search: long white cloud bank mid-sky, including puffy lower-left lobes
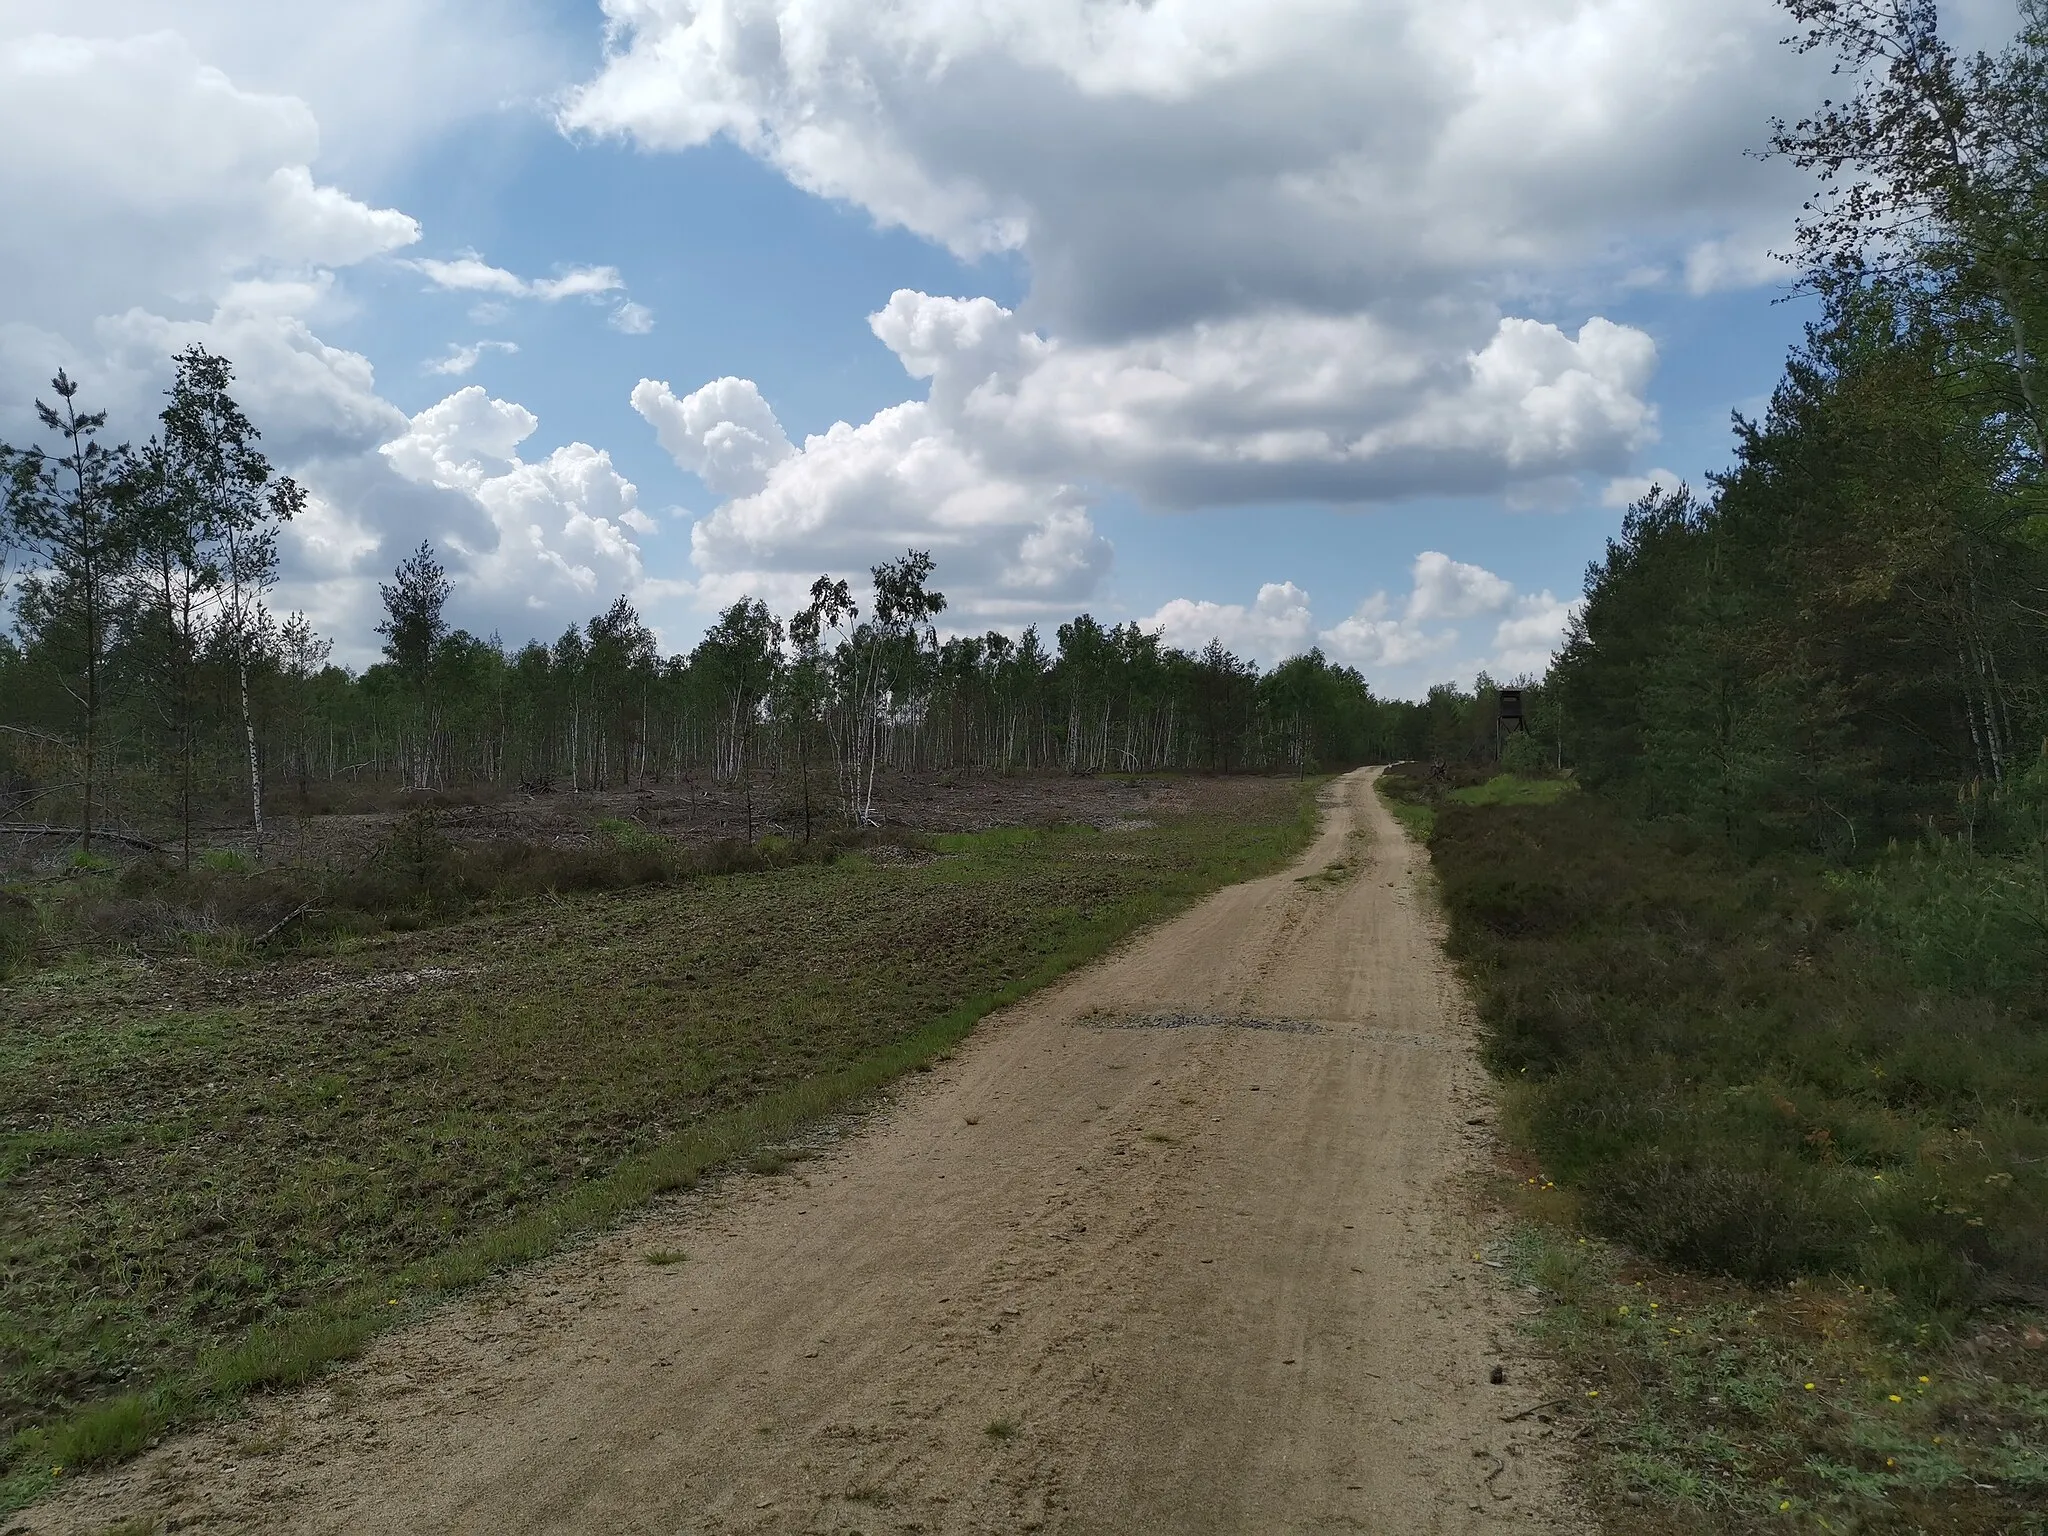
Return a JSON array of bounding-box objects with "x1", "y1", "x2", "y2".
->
[{"x1": 631, "y1": 289, "x2": 1655, "y2": 623}]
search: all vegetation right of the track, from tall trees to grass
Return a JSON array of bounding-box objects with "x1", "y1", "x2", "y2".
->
[{"x1": 1449, "y1": 0, "x2": 2048, "y2": 1536}]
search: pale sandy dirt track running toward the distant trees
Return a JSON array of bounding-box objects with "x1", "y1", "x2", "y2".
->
[{"x1": 19, "y1": 774, "x2": 1581, "y2": 1534}]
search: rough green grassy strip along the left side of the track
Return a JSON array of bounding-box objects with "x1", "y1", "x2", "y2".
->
[{"x1": 0, "y1": 780, "x2": 1315, "y2": 1507}]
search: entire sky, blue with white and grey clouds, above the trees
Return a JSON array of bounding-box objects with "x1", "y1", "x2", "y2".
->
[{"x1": 0, "y1": 0, "x2": 2009, "y2": 694}]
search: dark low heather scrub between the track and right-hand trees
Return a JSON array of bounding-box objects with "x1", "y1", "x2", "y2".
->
[{"x1": 1432, "y1": 795, "x2": 2048, "y2": 1325}]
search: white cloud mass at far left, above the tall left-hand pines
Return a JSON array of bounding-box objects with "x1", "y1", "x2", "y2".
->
[{"x1": 0, "y1": 25, "x2": 657, "y2": 664}]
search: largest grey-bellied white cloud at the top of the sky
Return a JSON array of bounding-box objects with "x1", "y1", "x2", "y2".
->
[{"x1": 561, "y1": 0, "x2": 1815, "y2": 334}]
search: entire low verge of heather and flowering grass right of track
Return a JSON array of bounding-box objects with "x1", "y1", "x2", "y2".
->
[{"x1": 1432, "y1": 795, "x2": 2048, "y2": 1536}]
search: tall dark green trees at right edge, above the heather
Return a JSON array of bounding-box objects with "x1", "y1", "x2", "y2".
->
[{"x1": 1550, "y1": 0, "x2": 2048, "y2": 860}]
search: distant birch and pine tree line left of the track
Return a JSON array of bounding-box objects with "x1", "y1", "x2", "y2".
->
[{"x1": 0, "y1": 358, "x2": 1523, "y2": 862}]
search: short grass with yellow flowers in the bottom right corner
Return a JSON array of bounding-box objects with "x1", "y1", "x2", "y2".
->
[{"x1": 1495, "y1": 1220, "x2": 2048, "y2": 1536}]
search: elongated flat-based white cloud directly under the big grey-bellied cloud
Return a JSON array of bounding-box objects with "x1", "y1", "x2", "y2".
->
[{"x1": 870, "y1": 289, "x2": 1657, "y2": 506}]
